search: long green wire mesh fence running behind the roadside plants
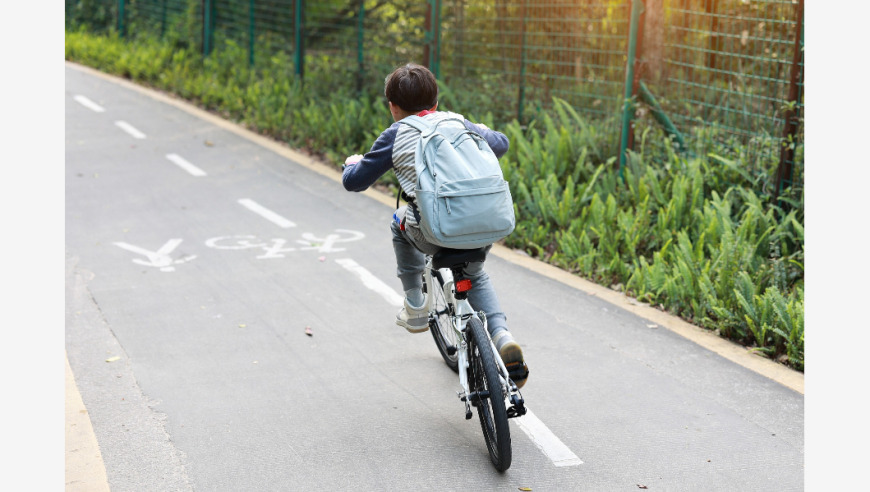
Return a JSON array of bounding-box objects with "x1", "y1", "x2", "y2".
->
[{"x1": 66, "y1": 0, "x2": 804, "y2": 195}]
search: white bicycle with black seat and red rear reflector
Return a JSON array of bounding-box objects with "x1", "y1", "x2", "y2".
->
[{"x1": 423, "y1": 248, "x2": 528, "y2": 472}]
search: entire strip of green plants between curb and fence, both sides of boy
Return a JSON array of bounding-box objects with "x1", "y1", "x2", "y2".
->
[{"x1": 66, "y1": 26, "x2": 804, "y2": 370}]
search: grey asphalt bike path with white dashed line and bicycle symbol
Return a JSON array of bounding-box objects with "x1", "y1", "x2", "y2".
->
[{"x1": 65, "y1": 64, "x2": 804, "y2": 490}]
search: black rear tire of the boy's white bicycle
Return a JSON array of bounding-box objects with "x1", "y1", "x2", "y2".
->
[{"x1": 468, "y1": 318, "x2": 512, "y2": 472}]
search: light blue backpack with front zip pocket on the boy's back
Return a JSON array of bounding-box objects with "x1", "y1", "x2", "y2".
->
[{"x1": 401, "y1": 113, "x2": 516, "y2": 249}]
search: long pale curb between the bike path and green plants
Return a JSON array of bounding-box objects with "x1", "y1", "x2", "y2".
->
[{"x1": 65, "y1": 61, "x2": 804, "y2": 395}]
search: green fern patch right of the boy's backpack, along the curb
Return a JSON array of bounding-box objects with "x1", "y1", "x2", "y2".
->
[{"x1": 502, "y1": 100, "x2": 804, "y2": 369}]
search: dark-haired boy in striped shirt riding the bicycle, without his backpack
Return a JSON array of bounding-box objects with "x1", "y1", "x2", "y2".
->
[{"x1": 342, "y1": 63, "x2": 527, "y2": 387}]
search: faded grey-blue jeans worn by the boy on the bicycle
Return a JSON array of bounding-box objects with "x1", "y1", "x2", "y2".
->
[{"x1": 390, "y1": 221, "x2": 507, "y2": 336}]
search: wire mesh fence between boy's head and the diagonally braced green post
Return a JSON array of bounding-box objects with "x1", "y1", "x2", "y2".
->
[{"x1": 440, "y1": 0, "x2": 628, "y2": 129}]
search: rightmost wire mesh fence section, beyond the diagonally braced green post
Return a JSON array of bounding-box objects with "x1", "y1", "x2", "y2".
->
[{"x1": 648, "y1": 0, "x2": 804, "y2": 192}]
